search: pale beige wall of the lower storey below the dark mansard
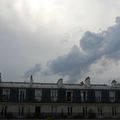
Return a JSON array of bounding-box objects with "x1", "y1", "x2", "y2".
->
[{"x1": 0, "y1": 103, "x2": 120, "y2": 118}]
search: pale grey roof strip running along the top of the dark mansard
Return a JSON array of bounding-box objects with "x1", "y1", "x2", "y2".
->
[{"x1": 0, "y1": 82, "x2": 120, "y2": 90}]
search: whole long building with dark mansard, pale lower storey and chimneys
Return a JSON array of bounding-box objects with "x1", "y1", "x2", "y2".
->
[{"x1": 0, "y1": 77, "x2": 120, "y2": 119}]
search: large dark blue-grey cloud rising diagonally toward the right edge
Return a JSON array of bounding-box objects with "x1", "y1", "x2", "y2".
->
[{"x1": 48, "y1": 17, "x2": 120, "y2": 83}]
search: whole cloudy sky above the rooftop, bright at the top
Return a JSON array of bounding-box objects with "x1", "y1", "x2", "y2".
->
[{"x1": 0, "y1": 0, "x2": 120, "y2": 84}]
